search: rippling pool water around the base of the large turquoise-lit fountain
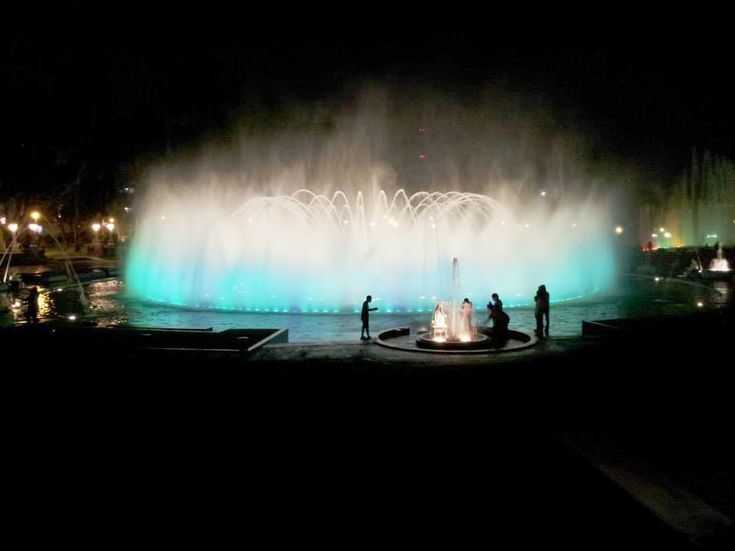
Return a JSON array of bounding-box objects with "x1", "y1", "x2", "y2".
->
[{"x1": 0, "y1": 277, "x2": 733, "y2": 342}]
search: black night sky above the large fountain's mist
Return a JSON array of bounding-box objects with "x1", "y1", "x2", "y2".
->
[{"x1": 0, "y1": 2, "x2": 735, "y2": 207}]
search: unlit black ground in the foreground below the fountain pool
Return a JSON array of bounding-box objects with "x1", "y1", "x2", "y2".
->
[{"x1": 3, "y1": 312, "x2": 735, "y2": 549}]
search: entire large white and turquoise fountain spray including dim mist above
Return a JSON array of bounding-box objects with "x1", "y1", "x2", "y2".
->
[{"x1": 125, "y1": 89, "x2": 616, "y2": 313}]
